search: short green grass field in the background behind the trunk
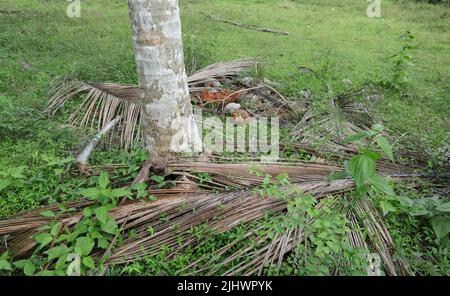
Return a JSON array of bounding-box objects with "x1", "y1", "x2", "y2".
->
[{"x1": 0, "y1": 0, "x2": 450, "y2": 151}]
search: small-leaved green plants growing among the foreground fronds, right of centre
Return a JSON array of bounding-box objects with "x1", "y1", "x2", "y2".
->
[{"x1": 248, "y1": 171, "x2": 367, "y2": 275}]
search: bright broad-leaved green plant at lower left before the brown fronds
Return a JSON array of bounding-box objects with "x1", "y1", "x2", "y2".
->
[{"x1": 5, "y1": 172, "x2": 131, "y2": 275}]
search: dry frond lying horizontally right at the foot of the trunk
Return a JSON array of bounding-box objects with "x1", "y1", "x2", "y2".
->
[{"x1": 0, "y1": 158, "x2": 420, "y2": 239}]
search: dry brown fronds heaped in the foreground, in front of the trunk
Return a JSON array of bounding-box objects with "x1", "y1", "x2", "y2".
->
[{"x1": 0, "y1": 163, "x2": 422, "y2": 275}]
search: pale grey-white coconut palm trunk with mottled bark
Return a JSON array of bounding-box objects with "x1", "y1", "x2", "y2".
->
[{"x1": 128, "y1": 0, "x2": 201, "y2": 158}]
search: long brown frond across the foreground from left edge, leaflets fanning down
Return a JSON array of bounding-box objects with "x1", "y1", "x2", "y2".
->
[{"x1": 0, "y1": 180, "x2": 353, "y2": 264}]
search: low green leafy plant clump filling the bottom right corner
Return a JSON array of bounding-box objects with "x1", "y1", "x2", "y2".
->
[{"x1": 384, "y1": 185, "x2": 450, "y2": 275}]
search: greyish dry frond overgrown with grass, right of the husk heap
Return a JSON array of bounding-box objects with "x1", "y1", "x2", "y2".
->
[{"x1": 281, "y1": 89, "x2": 428, "y2": 173}]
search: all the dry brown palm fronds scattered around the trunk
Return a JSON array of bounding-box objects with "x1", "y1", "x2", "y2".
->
[{"x1": 0, "y1": 60, "x2": 440, "y2": 275}]
